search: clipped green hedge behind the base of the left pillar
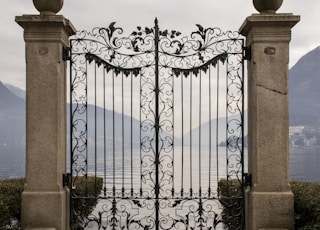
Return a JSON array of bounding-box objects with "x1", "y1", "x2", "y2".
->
[{"x1": 0, "y1": 177, "x2": 103, "y2": 230}]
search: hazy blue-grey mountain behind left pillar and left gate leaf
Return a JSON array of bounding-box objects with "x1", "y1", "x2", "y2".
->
[{"x1": 0, "y1": 82, "x2": 162, "y2": 179}]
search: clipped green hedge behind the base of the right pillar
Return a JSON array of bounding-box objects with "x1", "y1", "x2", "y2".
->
[{"x1": 219, "y1": 180, "x2": 320, "y2": 230}]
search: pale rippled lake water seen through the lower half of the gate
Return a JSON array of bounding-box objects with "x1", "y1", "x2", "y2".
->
[{"x1": 80, "y1": 146, "x2": 246, "y2": 230}]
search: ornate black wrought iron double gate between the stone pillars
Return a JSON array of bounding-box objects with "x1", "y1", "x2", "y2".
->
[{"x1": 69, "y1": 20, "x2": 245, "y2": 229}]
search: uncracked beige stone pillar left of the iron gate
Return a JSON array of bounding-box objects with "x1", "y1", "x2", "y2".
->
[{"x1": 16, "y1": 0, "x2": 75, "y2": 230}]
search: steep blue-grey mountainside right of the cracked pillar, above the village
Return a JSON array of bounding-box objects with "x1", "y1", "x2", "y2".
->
[{"x1": 289, "y1": 47, "x2": 320, "y2": 126}]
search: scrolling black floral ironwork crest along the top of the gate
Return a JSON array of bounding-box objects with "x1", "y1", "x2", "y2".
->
[{"x1": 74, "y1": 19, "x2": 242, "y2": 76}]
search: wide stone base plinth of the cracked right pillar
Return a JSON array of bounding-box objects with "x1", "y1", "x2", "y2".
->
[{"x1": 246, "y1": 191, "x2": 294, "y2": 230}]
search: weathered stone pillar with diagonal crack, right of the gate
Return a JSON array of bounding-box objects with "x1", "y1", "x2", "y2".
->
[{"x1": 240, "y1": 1, "x2": 300, "y2": 230}]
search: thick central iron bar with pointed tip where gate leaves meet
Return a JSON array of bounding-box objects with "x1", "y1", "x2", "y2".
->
[{"x1": 154, "y1": 18, "x2": 160, "y2": 230}]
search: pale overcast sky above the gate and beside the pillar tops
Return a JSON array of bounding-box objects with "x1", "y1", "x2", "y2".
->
[{"x1": 0, "y1": 0, "x2": 320, "y2": 89}]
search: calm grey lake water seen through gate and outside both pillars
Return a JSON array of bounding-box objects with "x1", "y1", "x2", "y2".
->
[{"x1": 0, "y1": 147, "x2": 320, "y2": 229}]
